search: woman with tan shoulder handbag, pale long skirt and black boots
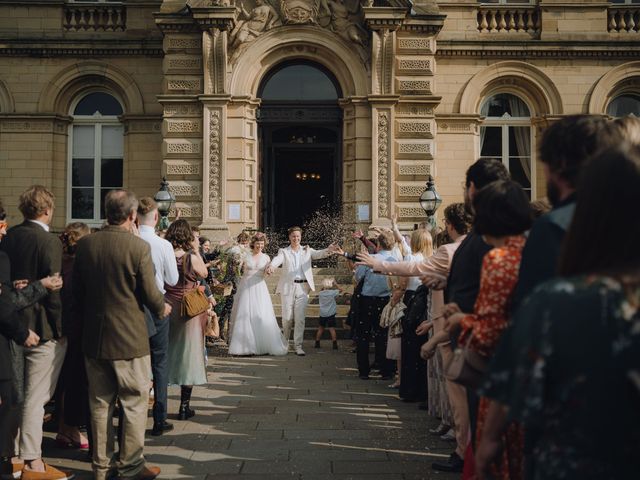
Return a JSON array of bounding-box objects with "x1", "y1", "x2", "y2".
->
[{"x1": 165, "y1": 219, "x2": 209, "y2": 420}]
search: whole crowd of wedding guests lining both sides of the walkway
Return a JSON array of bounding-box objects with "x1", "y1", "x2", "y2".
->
[{"x1": 0, "y1": 115, "x2": 640, "y2": 480}]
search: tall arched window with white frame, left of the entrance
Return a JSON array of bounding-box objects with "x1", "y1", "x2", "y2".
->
[{"x1": 67, "y1": 92, "x2": 124, "y2": 224}]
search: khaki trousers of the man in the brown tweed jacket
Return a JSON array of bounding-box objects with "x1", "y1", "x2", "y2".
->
[{"x1": 85, "y1": 355, "x2": 151, "y2": 480}]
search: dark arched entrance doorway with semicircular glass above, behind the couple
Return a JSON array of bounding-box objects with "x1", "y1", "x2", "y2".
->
[{"x1": 258, "y1": 61, "x2": 342, "y2": 230}]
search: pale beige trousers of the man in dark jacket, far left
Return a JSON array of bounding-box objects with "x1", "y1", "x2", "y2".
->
[{"x1": 20, "y1": 338, "x2": 67, "y2": 460}]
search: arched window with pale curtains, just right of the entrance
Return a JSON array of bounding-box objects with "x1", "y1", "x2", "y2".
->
[{"x1": 480, "y1": 93, "x2": 534, "y2": 198}]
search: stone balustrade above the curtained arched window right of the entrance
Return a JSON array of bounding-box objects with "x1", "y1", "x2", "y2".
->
[{"x1": 477, "y1": 5, "x2": 540, "y2": 33}]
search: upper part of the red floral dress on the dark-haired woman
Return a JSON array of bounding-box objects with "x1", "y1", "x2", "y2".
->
[{"x1": 459, "y1": 235, "x2": 525, "y2": 357}]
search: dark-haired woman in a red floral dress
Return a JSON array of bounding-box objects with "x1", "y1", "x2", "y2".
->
[{"x1": 445, "y1": 181, "x2": 531, "y2": 480}]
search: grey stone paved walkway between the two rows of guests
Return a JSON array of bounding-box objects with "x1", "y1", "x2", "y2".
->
[{"x1": 45, "y1": 341, "x2": 459, "y2": 480}]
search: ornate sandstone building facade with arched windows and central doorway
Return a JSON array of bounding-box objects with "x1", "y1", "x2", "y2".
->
[{"x1": 0, "y1": 0, "x2": 640, "y2": 237}]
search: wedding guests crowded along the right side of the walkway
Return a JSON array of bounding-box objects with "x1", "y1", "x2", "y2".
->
[{"x1": 352, "y1": 115, "x2": 640, "y2": 480}]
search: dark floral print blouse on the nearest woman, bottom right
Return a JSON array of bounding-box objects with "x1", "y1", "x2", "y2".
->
[{"x1": 483, "y1": 276, "x2": 640, "y2": 480}]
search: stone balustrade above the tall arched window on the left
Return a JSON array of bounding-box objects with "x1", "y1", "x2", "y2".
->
[{"x1": 62, "y1": 3, "x2": 127, "y2": 31}]
